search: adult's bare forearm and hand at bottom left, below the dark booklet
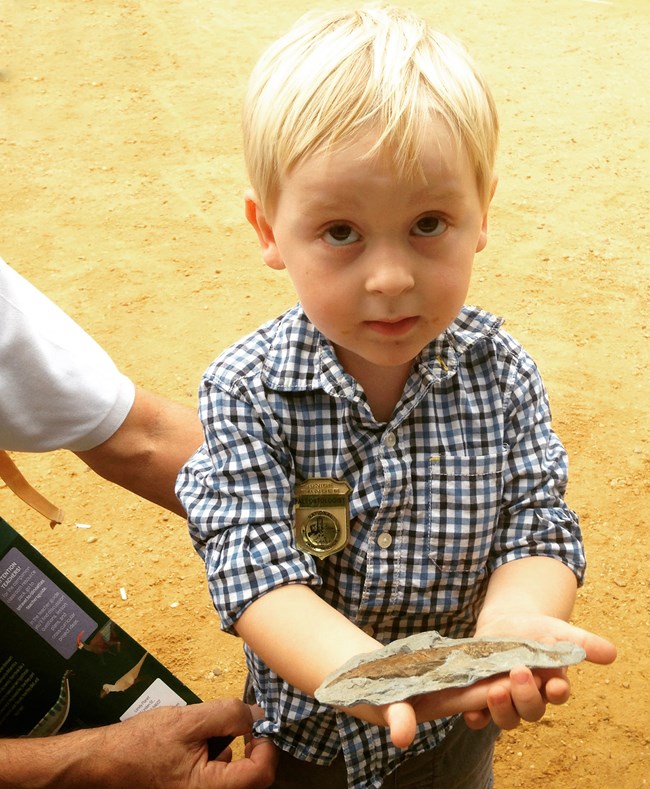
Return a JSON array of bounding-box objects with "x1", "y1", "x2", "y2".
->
[{"x1": 0, "y1": 699, "x2": 277, "y2": 789}]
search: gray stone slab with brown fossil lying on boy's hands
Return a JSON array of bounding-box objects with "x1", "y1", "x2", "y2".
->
[{"x1": 315, "y1": 631, "x2": 585, "y2": 707}]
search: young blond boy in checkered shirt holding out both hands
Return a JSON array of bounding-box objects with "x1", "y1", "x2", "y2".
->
[{"x1": 178, "y1": 7, "x2": 614, "y2": 789}]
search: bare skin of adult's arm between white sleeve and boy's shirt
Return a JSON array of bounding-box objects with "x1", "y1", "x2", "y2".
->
[{"x1": 75, "y1": 387, "x2": 203, "y2": 517}]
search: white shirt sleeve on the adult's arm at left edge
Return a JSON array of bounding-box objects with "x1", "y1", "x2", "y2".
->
[{"x1": 0, "y1": 260, "x2": 135, "y2": 452}]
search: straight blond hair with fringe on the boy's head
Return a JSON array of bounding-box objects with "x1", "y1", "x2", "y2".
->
[{"x1": 242, "y1": 5, "x2": 498, "y2": 211}]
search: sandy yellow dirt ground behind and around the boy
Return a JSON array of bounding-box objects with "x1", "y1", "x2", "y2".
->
[{"x1": 0, "y1": 0, "x2": 650, "y2": 789}]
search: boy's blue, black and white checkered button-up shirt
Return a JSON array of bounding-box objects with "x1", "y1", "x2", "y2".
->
[{"x1": 178, "y1": 306, "x2": 585, "y2": 789}]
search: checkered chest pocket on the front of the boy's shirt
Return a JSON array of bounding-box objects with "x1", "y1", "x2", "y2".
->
[{"x1": 427, "y1": 447, "x2": 507, "y2": 573}]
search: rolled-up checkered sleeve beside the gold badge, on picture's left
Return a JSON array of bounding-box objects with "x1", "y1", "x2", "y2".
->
[{"x1": 177, "y1": 379, "x2": 321, "y2": 633}]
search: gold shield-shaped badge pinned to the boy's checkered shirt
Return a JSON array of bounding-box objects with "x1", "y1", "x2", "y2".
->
[{"x1": 295, "y1": 477, "x2": 352, "y2": 559}]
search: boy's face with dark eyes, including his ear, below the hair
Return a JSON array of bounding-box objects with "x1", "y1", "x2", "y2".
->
[{"x1": 246, "y1": 120, "x2": 487, "y2": 378}]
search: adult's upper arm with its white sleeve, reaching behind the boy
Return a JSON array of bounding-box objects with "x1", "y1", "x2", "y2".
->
[{"x1": 0, "y1": 260, "x2": 203, "y2": 516}]
